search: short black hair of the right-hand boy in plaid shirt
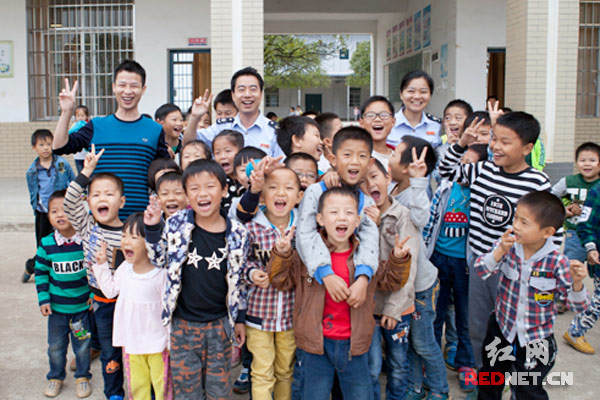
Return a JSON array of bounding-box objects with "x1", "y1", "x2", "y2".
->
[{"x1": 517, "y1": 190, "x2": 566, "y2": 230}]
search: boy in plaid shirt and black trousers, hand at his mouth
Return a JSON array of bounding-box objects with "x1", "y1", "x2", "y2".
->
[{"x1": 475, "y1": 191, "x2": 587, "y2": 400}]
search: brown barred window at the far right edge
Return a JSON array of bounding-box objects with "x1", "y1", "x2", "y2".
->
[{"x1": 577, "y1": 0, "x2": 600, "y2": 117}]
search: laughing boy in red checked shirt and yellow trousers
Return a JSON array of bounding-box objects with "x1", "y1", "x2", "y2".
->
[{"x1": 244, "y1": 168, "x2": 302, "y2": 399}]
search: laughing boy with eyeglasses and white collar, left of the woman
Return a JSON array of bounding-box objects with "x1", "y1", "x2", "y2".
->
[{"x1": 359, "y1": 96, "x2": 396, "y2": 170}]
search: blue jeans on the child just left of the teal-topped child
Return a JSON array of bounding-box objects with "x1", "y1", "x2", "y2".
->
[{"x1": 408, "y1": 280, "x2": 448, "y2": 393}]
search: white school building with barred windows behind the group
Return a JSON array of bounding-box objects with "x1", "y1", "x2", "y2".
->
[{"x1": 0, "y1": 0, "x2": 600, "y2": 178}]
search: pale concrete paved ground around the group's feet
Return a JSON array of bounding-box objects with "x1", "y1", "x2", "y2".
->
[{"x1": 0, "y1": 179, "x2": 600, "y2": 400}]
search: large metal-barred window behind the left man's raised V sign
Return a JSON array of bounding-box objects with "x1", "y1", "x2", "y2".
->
[{"x1": 27, "y1": 0, "x2": 134, "y2": 121}]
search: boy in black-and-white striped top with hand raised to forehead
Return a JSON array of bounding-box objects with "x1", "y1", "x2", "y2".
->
[{"x1": 439, "y1": 112, "x2": 551, "y2": 378}]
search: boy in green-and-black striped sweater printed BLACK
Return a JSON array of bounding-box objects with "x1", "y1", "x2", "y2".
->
[{"x1": 35, "y1": 190, "x2": 92, "y2": 398}]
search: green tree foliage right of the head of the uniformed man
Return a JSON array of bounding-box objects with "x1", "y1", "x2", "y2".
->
[{"x1": 264, "y1": 35, "x2": 345, "y2": 88}]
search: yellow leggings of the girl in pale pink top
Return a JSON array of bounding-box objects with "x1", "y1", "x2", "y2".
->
[{"x1": 123, "y1": 349, "x2": 173, "y2": 400}]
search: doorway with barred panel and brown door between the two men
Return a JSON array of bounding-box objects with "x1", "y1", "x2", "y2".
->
[{"x1": 169, "y1": 50, "x2": 211, "y2": 113}]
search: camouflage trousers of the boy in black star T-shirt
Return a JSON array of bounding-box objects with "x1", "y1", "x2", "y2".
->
[{"x1": 171, "y1": 317, "x2": 231, "y2": 400}]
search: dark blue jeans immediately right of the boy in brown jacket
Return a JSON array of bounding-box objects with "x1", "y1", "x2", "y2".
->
[{"x1": 369, "y1": 315, "x2": 411, "y2": 400}]
